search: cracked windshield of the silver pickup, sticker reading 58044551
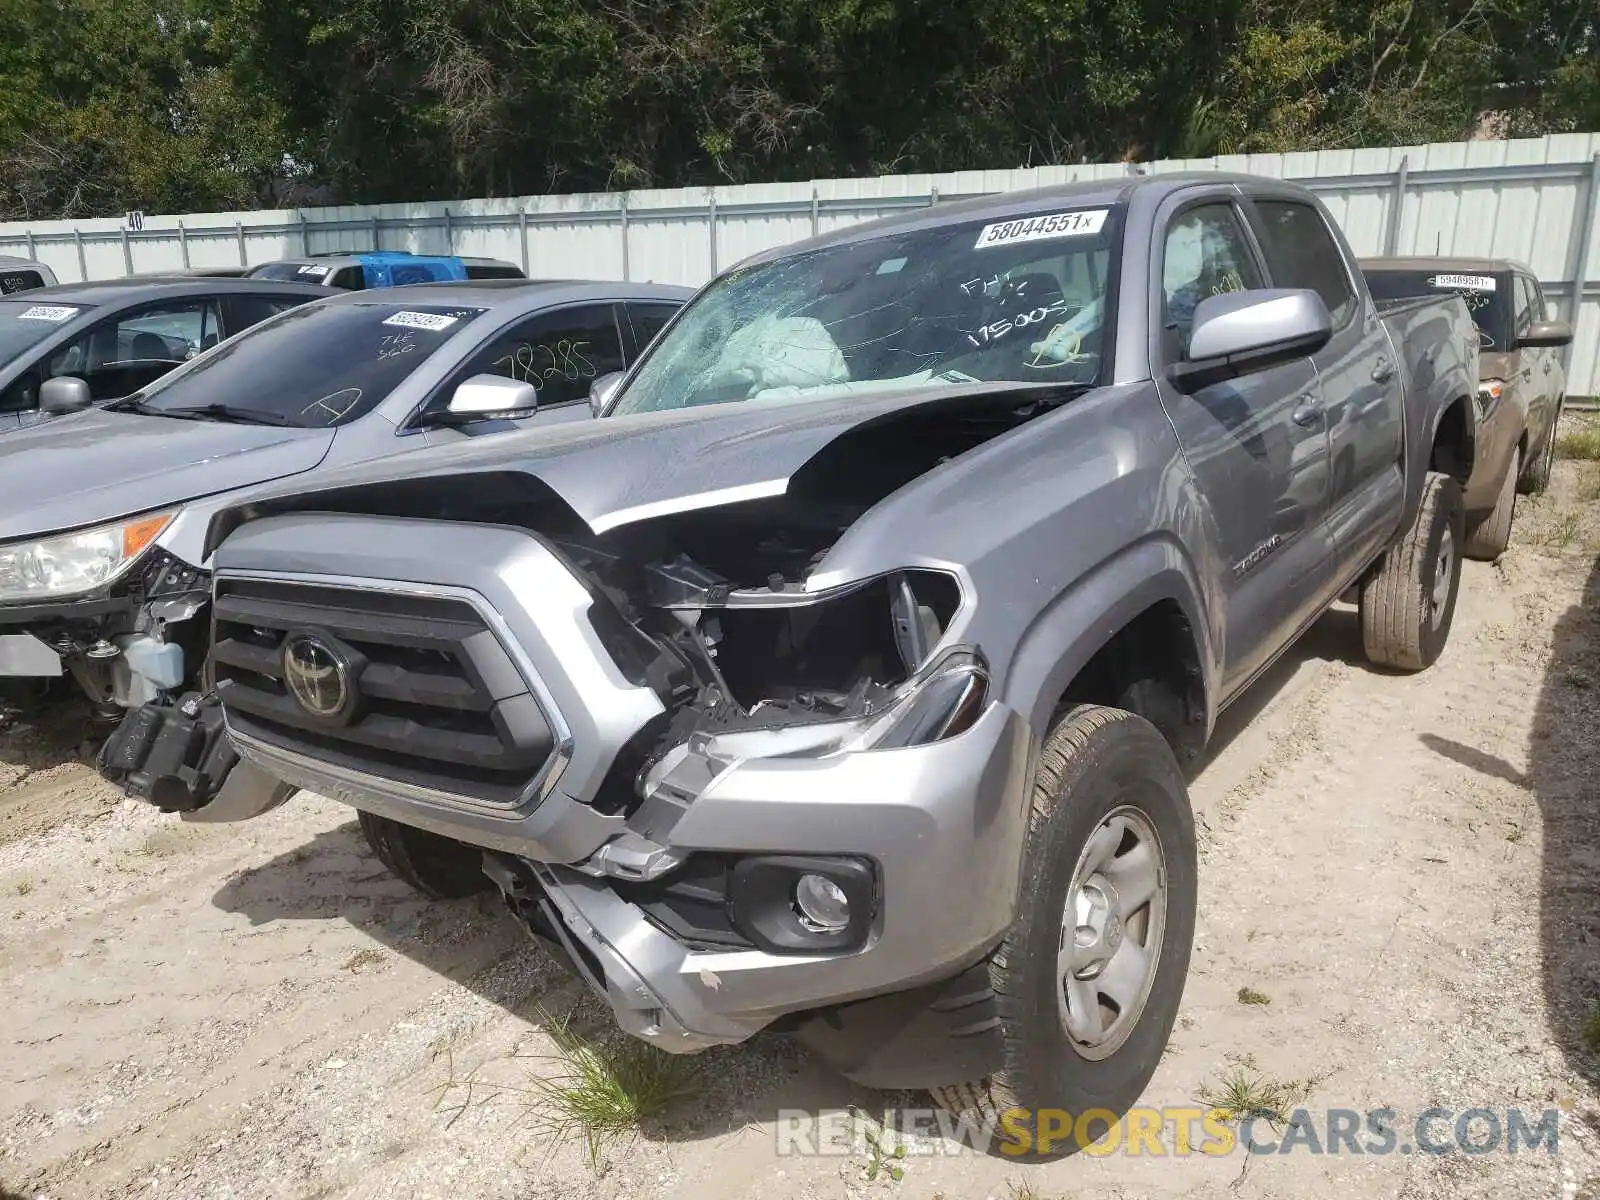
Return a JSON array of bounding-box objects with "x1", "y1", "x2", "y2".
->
[{"x1": 613, "y1": 208, "x2": 1115, "y2": 414}]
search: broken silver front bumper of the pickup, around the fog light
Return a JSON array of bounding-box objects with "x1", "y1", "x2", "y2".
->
[{"x1": 243, "y1": 704, "x2": 1030, "y2": 1051}]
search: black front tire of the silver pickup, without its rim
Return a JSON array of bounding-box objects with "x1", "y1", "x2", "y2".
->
[{"x1": 933, "y1": 704, "x2": 1197, "y2": 1158}]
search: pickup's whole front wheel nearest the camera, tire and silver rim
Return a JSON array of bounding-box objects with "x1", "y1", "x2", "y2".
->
[{"x1": 934, "y1": 706, "x2": 1197, "y2": 1157}]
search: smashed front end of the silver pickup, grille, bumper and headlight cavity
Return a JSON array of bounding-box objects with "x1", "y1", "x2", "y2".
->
[{"x1": 90, "y1": 389, "x2": 1066, "y2": 1086}]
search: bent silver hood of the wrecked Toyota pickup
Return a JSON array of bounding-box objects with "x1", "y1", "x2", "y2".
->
[{"x1": 211, "y1": 384, "x2": 1054, "y2": 546}]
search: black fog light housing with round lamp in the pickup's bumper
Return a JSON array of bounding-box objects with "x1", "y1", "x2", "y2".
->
[{"x1": 728, "y1": 854, "x2": 877, "y2": 954}]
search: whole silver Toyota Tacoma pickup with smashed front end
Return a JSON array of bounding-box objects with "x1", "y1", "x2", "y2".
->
[{"x1": 106, "y1": 174, "x2": 1478, "y2": 1152}]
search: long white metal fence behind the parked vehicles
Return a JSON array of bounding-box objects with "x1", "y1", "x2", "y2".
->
[{"x1": 0, "y1": 133, "x2": 1600, "y2": 395}]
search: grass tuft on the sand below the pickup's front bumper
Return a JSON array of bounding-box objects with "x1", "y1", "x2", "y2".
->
[{"x1": 533, "y1": 1016, "x2": 699, "y2": 1168}]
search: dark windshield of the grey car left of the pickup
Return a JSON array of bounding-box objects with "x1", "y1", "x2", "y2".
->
[{"x1": 122, "y1": 302, "x2": 483, "y2": 429}]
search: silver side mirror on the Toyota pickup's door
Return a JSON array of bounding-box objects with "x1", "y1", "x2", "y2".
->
[{"x1": 1168, "y1": 288, "x2": 1333, "y2": 395}]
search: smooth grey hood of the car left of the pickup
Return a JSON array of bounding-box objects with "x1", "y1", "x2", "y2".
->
[{"x1": 0, "y1": 408, "x2": 334, "y2": 542}]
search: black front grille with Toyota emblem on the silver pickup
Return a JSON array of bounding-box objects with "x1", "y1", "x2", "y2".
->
[{"x1": 211, "y1": 578, "x2": 558, "y2": 808}]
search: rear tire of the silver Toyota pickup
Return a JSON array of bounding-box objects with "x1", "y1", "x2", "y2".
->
[{"x1": 1362, "y1": 470, "x2": 1466, "y2": 670}]
